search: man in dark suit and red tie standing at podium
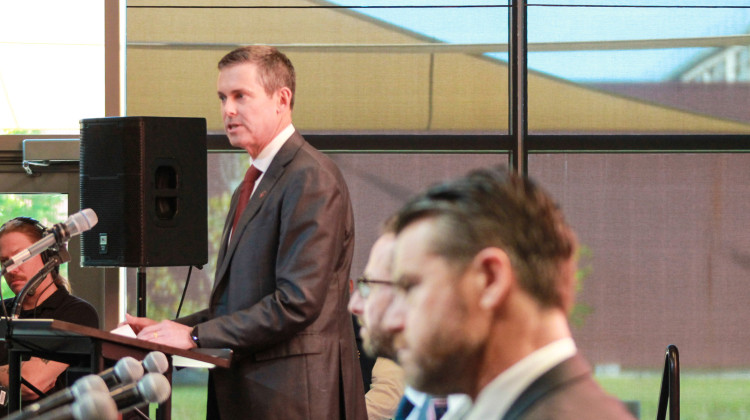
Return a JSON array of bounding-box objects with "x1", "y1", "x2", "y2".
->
[{"x1": 127, "y1": 46, "x2": 366, "y2": 420}]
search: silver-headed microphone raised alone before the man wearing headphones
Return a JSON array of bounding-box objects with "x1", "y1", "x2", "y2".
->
[{"x1": 2, "y1": 209, "x2": 99, "y2": 273}]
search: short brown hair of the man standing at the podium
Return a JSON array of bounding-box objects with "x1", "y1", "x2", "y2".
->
[{"x1": 219, "y1": 45, "x2": 296, "y2": 109}]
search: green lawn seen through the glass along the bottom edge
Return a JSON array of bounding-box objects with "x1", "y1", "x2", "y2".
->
[{"x1": 151, "y1": 372, "x2": 750, "y2": 420}]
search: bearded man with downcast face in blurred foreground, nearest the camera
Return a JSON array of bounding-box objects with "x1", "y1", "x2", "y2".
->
[{"x1": 383, "y1": 169, "x2": 632, "y2": 420}]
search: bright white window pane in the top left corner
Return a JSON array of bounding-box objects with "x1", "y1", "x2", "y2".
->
[{"x1": 0, "y1": 0, "x2": 104, "y2": 134}]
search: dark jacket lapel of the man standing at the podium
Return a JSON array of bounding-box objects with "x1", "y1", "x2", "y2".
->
[{"x1": 212, "y1": 131, "x2": 304, "y2": 301}]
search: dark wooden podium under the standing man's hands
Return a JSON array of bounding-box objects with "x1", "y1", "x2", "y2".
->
[{"x1": 0, "y1": 318, "x2": 232, "y2": 420}]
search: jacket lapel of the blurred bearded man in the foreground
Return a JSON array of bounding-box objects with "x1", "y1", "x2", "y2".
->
[{"x1": 503, "y1": 354, "x2": 591, "y2": 420}]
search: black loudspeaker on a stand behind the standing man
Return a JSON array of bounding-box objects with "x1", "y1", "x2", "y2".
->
[{"x1": 80, "y1": 117, "x2": 208, "y2": 267}]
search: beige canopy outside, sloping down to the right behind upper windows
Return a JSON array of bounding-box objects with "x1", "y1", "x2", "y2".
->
[{"x1": 126, "y1": 0, "x2": 750, "y2": 133}]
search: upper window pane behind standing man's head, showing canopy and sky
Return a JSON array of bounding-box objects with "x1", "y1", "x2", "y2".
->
[{"x1": 127, "y1": 0, "x2": 508, "y2": 132}]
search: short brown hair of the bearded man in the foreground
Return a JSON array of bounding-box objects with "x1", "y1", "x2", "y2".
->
[{"x1": 395, "y1": 167, "x2": 577, "y2": 310}]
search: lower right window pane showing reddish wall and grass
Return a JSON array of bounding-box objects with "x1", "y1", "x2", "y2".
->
[{"x1": 529, "y1": 154, "x2": 750, "y2": 419}]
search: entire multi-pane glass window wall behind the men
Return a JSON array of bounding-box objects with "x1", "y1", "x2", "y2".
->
[{"x1": 0, "y1": 0, "x2": 750, "y2": 419}]
